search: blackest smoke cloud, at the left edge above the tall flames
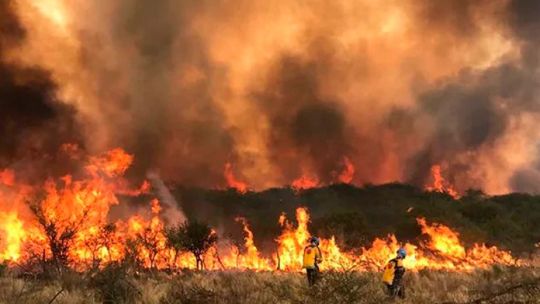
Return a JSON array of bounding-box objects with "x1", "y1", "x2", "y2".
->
[{"x1": 0, "y1": 1, "x2": 80, "y2": 176}]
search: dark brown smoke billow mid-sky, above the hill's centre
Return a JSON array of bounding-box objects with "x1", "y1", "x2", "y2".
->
[{"x1": 255, "y1": 56, "x2": 353, "y2": 183}]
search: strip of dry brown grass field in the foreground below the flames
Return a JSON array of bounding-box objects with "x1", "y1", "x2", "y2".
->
[{"x1": 0, "y1": 265, "x2": 540, "y2": 304}]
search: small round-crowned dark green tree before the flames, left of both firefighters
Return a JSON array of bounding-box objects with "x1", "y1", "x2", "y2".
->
[{"x1": 166, "y1": 220, "x2": 217, "y2": 270}]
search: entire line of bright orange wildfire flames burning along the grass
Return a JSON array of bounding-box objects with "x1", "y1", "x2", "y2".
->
[{"x1": 0, "y1": 149, "x2": 520, "y2": 271}]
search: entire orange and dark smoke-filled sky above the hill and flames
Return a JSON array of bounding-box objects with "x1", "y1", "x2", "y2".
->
[{"x1": 0, "y1": 0, "x2": 540, "y2": 192}]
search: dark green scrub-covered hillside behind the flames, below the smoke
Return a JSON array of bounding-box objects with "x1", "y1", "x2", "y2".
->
[{"x1": 173, "y1": 183, "x2": 540, "y2": 255}]
